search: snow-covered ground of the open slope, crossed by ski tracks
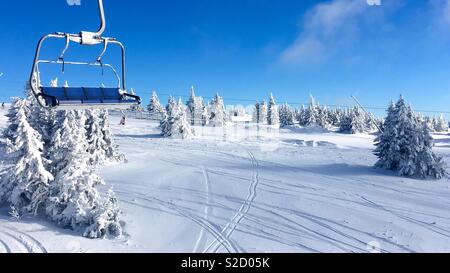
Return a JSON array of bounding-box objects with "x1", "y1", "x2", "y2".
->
[{"x1": 0, "y1": 107, "x2": 450, "y2": 253}]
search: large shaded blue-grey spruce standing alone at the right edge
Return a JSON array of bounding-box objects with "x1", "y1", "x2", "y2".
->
[{"x1": 374, "y1": 97, "x2": 445, "y2": 179}]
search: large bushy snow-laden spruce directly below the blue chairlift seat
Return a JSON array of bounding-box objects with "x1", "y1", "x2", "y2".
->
[{"x1": 46, "y1": 111, "x2": 122, "y2": 238}]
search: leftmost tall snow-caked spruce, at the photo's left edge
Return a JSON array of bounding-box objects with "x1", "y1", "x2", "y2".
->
[{"x1": 0, "y1": 96, "x2": 53, "y2": 214}]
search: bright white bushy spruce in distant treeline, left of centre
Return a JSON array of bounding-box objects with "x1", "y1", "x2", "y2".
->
[{"x1": 161, "y1": 99, "x2": 194, "y2": 139}]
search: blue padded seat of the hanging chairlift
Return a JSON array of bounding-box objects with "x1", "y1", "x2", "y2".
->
[{"x1": 40, "y1": 87, "x2": 140, "y2": 109}]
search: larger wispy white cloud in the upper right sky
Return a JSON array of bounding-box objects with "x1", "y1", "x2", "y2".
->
[{"x1": 280, "y1": 0, "x2": 374, "y2": 64}]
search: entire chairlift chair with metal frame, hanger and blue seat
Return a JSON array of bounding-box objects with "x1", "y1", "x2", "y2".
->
[{"x1": 30, "y1": 0, "x2": 141, "y2": 110}]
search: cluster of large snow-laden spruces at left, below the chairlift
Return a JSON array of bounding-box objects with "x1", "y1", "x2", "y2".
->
[{"x1": 0, "y1": 84, "x2": 124, "y2": 238}]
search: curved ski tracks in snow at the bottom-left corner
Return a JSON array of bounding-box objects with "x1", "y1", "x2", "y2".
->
[{"x1": 0, "y1": 226, "x2": 47, "y2": 253}]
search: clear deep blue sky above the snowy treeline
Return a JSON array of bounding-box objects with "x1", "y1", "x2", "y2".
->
[{"x1": 0, "y1": 0, "x2": 450, "y2": 115}]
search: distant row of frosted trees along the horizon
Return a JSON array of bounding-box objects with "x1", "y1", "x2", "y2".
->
[{"x1": 147, "y1": 88, "x2": 449, "y2": 137}]
